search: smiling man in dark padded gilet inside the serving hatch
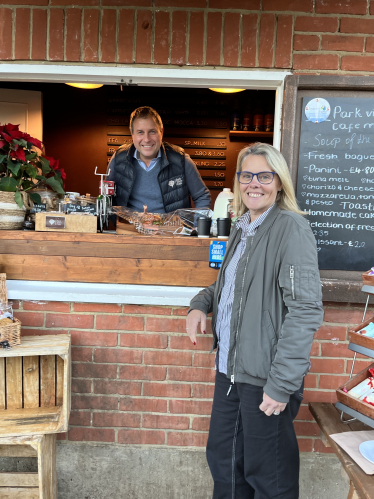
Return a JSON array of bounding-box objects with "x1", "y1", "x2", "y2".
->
[{"x1": 107, "y1": 106, "x2": 210, "y2": 213}]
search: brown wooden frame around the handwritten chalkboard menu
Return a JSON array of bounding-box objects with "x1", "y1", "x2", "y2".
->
[{"x1": 281, "y1": 75, "x2": 374, "y2": 303}]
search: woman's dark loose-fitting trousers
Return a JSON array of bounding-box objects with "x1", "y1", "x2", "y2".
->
[{"x1": 207, "y1": 372, "x2": 303, "y2": 499}]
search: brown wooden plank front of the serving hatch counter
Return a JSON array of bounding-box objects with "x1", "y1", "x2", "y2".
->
[{"x1": 0, "y1": 230, "x2": 217, "y2": 287}]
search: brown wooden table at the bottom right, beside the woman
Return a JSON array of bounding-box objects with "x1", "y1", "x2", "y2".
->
[{"x1": 309, "y1": 402, "x2": 374, "y2": 499}]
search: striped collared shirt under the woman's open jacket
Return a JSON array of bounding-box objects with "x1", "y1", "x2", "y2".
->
[{"x1": 216, "y1": 205, "x2": 274, "y2": 374}]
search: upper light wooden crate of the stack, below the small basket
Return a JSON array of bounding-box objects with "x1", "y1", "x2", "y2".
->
[{"x1": 0, "y1": 334, "x2": 71, "y2": 437}]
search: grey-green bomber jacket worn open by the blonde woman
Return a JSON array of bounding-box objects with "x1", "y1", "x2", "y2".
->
[{"x1": 191, "y1": 206, "x2": 323, "y2": 402}]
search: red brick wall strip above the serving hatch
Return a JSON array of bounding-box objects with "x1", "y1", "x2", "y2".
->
[{"x1": 0, "y1": 0, "x2": 374, "y2": 74}]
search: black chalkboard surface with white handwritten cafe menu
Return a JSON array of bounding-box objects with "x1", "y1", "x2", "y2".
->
[{"x1": 297, "y1": 97, "x2": 374, "y2": 271}]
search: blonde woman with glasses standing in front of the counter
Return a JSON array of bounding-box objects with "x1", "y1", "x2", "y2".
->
[{"x1": 186, "y1": 143, "x2": 323, "y2": 499}]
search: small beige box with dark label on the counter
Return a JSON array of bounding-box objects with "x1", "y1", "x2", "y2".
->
[{"x1": 35, "y1": 211, "x2": 97, "y2": 234}]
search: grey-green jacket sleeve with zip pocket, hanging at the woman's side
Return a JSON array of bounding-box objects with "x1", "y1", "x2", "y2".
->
[{"x1": 264, "y1": 221, "x2": 323, "y2": 402}]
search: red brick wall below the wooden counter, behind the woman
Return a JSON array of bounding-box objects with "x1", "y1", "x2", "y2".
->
[{"x1": 14, "y1": 301, "x2": 374, "y2": 452}]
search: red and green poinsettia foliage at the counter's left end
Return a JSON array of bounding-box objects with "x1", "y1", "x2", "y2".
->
[{"x1": 0, "y1": 123, "x2": 66, "y2": 208}]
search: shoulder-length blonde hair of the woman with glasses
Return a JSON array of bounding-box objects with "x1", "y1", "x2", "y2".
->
[{"x1": 234, "y1": 142, "x2": 306, "y2": 217}]
